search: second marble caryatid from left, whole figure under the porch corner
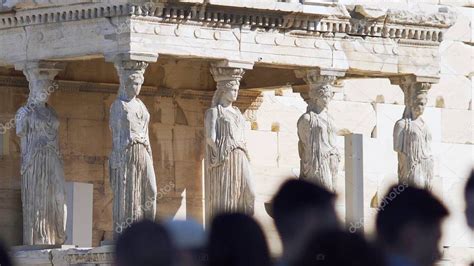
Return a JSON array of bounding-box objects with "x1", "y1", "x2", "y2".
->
[{"x1": 109, "y1": 60, "x2": 157, "y2": 233}]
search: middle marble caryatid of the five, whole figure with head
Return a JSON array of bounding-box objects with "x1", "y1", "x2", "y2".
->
[{"x1": 205, "y1": 67, "x2": 255, "y2": 218}]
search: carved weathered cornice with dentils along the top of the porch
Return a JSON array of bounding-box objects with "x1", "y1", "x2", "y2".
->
[{"x1": 0, "y1": 3, "x2": 455, "y2": 43}]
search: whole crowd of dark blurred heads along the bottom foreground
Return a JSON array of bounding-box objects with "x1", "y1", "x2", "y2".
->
[{"x1": 0, "y1": 171, "x2": 474, "y2": 266}]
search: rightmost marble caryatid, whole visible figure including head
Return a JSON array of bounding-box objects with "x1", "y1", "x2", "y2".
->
[{"x1": 393, "y1": 77, "x2": 434, "y2": 190}]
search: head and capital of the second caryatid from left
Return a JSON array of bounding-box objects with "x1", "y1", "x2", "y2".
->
[{"x1": 115, "y1": 61, "x2": 148, "y2": 101}]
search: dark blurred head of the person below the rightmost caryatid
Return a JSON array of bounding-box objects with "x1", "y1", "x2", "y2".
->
[{"x1": 376, "y1": 186, "x2": 448, "y2": 266}]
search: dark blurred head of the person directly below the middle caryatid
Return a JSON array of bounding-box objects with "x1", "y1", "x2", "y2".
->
[{"x1": 208, "y1": 213, "x2": 271, "y2": 266}]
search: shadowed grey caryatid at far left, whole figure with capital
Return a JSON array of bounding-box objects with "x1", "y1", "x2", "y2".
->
[{"x1": 15, "y1": 63, "x2": 67, "y2": 245}]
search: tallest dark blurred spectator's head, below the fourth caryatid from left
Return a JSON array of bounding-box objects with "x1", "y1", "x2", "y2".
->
[{"x1": 272, "y1": 179, "x2": 340, "y2": 265}]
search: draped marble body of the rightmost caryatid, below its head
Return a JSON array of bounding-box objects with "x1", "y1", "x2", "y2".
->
[{"x1": 393, "y1": 117, "x2": 434, "y2": 189}]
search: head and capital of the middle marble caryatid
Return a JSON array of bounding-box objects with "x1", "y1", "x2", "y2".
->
[{"x1": 211, "y1": 68, "x2": 244, "y2": 106}]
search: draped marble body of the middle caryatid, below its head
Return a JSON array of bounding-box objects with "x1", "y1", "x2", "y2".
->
[{"x1": 206, "y1": 105, "x2": 255, "y2": 217}]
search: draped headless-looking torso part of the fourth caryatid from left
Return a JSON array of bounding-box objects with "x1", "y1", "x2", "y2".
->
[{"x1": 297, "y1": 110, "x2": 340, "y2": 191}]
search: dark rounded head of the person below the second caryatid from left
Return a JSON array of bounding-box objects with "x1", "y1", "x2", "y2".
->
[{"x1": 115, "y1": 220, "x2": 174, "y2": 266}]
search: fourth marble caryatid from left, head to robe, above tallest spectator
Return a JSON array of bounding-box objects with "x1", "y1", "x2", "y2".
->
[{"x1": 297, "y1": 72, "x2": 340, "y2": 191}]
